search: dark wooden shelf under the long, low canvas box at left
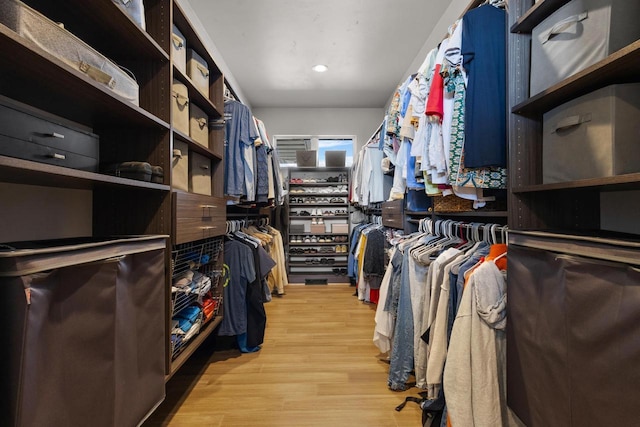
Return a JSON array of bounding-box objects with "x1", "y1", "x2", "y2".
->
[{"x1": 0, "y1": 25, "x2": 169, "y2": 130}]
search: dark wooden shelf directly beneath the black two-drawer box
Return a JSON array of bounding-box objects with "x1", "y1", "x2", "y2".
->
[{"x1": 0, "y1": 156, "x2": 170, "y2": 191}]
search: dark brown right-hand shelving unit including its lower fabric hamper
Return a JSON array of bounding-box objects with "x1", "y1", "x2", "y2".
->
[{"x1": 507, "y1": 0, "x2": 640, "y2": 427}]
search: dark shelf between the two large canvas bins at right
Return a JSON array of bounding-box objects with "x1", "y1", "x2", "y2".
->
[{"x1": 511, "y1": 40, "x2": 640, "y2": 119}]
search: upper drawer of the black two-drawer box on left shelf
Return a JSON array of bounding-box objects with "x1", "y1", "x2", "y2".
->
[{"x1": 0, "y1": 105, "x2": 99, "y2": 160}]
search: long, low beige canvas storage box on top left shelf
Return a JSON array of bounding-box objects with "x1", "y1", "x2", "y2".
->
[{"x1": 0, "y1": 0, "x2": 139, "y2": 105}]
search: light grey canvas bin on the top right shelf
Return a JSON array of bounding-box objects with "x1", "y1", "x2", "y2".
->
[{"x1": 530, "y1": 0, "x2": 640, "y2": 96}]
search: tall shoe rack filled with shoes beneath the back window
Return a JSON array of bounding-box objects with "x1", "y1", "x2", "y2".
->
[{"x1": 287, "y1": 167, "x2": 350, "y2": 284}]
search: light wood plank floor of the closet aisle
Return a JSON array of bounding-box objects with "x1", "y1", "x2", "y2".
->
[{"x1": 144, "y1": 284, "x2": 421, "y2": 427}]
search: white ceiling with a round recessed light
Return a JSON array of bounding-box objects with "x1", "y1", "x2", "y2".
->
[{"x1": 182, "y1": 0, "x2": 458, "y2": 108}]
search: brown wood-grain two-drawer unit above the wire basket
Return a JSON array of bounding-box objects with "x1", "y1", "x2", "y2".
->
[{"x1": 173, "y1": 192, "x2": 226, "y2": 244}]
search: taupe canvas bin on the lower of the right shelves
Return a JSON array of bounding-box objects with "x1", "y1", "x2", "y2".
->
[{"x1": 542, "y1": 83, "x2": 640, "y2": 184}]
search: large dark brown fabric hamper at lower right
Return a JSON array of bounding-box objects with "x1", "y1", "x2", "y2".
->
[{"x1": 507, "y1": 230, "x2": 640, "y2": 427}]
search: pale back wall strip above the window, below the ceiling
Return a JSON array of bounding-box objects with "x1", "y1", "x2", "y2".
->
[{"x1": 252, "y1": 108, "x2": 384, "y2": 150}]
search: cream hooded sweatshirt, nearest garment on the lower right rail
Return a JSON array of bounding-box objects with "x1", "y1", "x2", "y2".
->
[{"x1": 444, "y1": 261, "x2": 510, "y2": 427}]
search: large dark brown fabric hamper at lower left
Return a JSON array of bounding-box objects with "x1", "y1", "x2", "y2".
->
[{"x1": 0, "y1": 236, "x2": 168, "y2": 427}]
